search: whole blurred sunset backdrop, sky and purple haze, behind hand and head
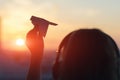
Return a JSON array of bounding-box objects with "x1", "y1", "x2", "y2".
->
[{"x1": 0, "y1": 0, "x2": 120, "y2": 80}]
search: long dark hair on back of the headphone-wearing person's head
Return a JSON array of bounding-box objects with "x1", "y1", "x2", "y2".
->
[{"x1": 59, "y1": 29, "x2": 119, "y2": 80}]
